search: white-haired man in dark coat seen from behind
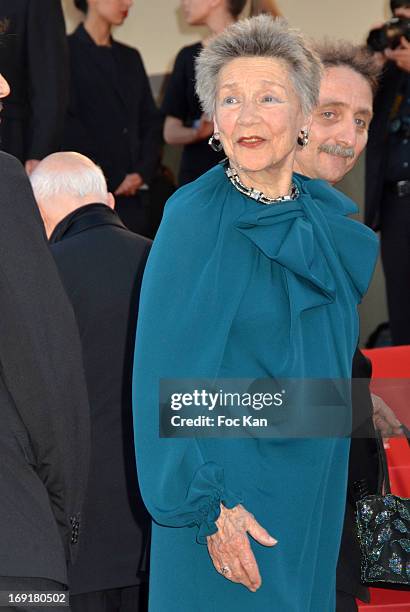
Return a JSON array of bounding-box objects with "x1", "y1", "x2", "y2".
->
[{"x1": 31, "y1": 153, "x2": 150, "y2": 612}]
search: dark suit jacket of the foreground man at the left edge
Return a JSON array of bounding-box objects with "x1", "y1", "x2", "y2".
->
[{"x1": 0, "y1": 153, "x2": 89, "y2": 584}]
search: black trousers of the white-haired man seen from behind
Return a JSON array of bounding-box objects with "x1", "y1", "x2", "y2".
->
[{"x1": 70, "y1": 583, "x2": 148, "y2": 612}]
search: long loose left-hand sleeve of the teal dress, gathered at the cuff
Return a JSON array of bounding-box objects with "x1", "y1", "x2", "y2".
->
[{"x1": 134, "y1": 169, "x2": 250, "y2": 541}]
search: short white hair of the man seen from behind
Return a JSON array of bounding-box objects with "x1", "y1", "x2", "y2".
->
[{"x1": 30, "y1": 157, "x2": 108, "y2": 202}]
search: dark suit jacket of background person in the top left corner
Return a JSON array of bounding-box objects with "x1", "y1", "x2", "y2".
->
[{"x1": 0, "y1": 0, "x2": 68, "y2": 162}]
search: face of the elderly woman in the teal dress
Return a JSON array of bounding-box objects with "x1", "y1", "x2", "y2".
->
[{"x1": 214, "y1": 57, "x2": 307, "y2": 172}]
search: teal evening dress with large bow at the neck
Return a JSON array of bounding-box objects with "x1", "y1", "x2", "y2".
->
[{"x1": 133, "y1": 165, "x2": 378, "y2": 612}]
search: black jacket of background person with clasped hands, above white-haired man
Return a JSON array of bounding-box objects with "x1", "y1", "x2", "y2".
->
[{"x1": 63, "y1": 25, "x2": 161, "y2": 191}]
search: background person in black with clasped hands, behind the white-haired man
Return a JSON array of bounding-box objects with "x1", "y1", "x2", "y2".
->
[{"x1": 63, "y1": 0, "x2": 161, "y2": 235}]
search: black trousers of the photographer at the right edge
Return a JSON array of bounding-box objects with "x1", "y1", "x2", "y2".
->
[{"x1": 381, "y1": 192, "x2": 410, "y2": 345}]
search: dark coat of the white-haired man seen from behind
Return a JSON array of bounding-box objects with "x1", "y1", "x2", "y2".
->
[{"x1": 50, "y1": 204, "x2": 150, "y2": 594}]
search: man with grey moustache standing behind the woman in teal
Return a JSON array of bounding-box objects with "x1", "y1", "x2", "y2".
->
[{"x1": 295, "y1": 41, "x2": 401, "y2": 612}]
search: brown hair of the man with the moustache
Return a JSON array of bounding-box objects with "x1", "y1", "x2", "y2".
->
[{"x1": 315, "y1": 40, "x2": 381, "y2": 96}]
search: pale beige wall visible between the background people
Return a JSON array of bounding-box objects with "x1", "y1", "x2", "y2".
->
[{"x1": 62, "y1": 0, "x2": 389, "y2": 341}]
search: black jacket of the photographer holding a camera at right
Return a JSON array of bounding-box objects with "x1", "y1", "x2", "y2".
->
[{"x1": 364, "y1": 62, "x2": 407, "y2": 230}]
